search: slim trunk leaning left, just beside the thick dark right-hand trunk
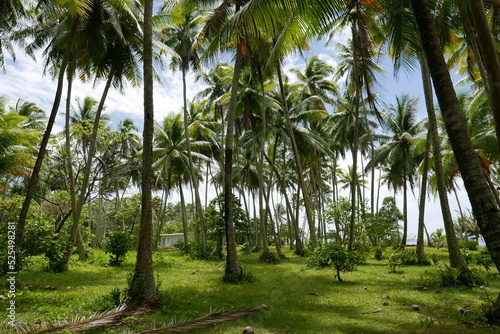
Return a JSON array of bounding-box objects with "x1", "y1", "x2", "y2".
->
[{"x1": 420, "y1": 53, "x2": 474, "y2": 283}]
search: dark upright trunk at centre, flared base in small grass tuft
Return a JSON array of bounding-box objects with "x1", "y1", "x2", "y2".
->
[{"x1": 224, "y1": 28, "x2": 243, "y2": 282}]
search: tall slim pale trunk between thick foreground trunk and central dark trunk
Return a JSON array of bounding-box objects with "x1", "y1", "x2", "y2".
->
[{"x1": 182, "y1": 66, "x2": 207, "y2": 255}]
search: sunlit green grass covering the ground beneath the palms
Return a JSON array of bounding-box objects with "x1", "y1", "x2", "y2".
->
[{"x1": 0, "y1": 249, "x2": 500, "y2": 334}]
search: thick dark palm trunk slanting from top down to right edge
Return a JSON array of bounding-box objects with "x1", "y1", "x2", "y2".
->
[{"x1": 411, "y1": 0, "x2": 492, "y2": 288}]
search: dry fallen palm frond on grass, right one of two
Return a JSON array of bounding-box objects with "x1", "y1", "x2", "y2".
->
[{"x1": 143, "y1": 304, "x2": 269, "y2": 333}]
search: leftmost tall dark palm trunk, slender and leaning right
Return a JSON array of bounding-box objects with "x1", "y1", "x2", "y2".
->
[{"x1": 14, "y1": 20, "x2": 78, "y2": 270}]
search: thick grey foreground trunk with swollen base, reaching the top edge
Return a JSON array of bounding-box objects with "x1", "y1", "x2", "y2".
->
[{"x1": 128, "y1": 0, "x2": 157, "y2": 304}]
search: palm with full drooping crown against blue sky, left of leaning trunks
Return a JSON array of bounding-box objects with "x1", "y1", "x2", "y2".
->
[{"x1": 370, "y1": 94, "x2": 421, "y2": 247}]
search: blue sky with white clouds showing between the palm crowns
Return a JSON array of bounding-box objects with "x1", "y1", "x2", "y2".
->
[{"x1": 0, "y1": 24, "x2": 470, "y2": 243}]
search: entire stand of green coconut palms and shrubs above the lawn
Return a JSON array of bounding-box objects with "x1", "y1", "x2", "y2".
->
[{"x1": 0, "y1": 0, "x2": 500, "y2": 330}]
